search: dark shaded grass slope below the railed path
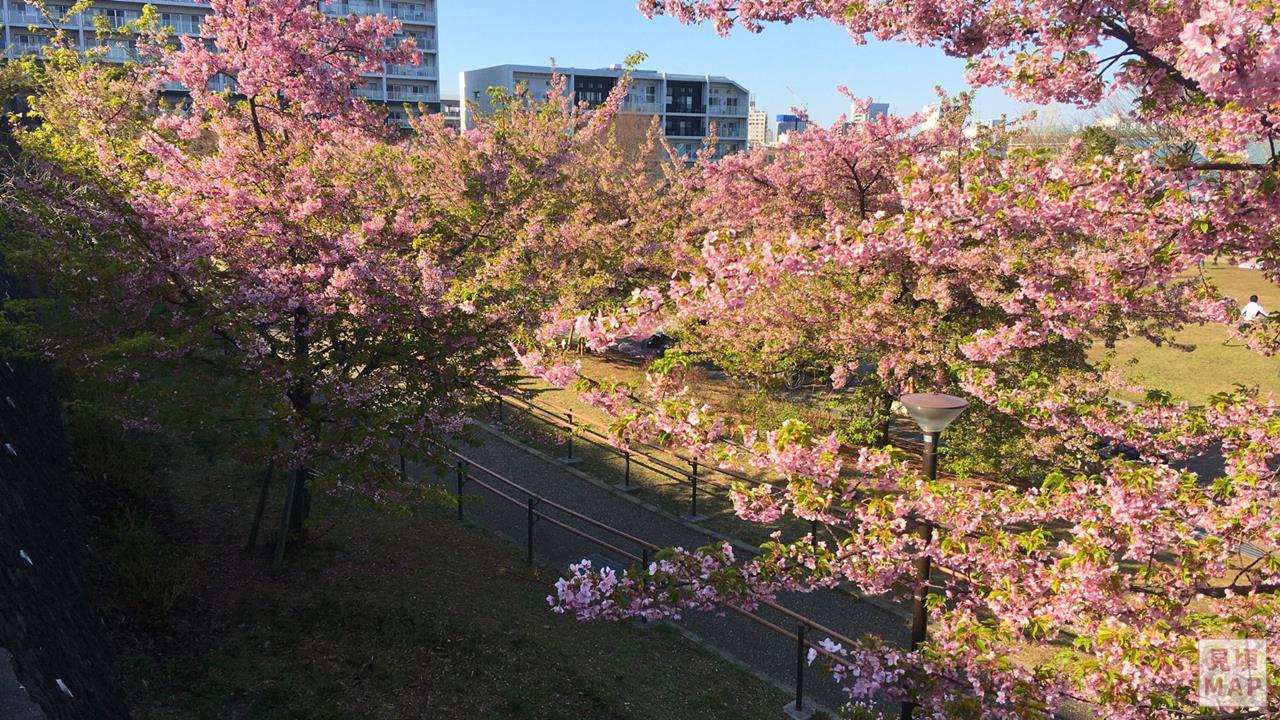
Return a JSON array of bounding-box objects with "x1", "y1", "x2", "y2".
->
[{"x1": 90, "y1": 427, "x2": 788, "y2": 720}]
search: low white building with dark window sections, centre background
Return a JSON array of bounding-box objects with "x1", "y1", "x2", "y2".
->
[{"x1": 458, "y1": 65, "x2": 750, "y2": 158}]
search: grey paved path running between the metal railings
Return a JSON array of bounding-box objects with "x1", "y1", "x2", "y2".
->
[{"x1": 425, "y1": 417, "x2": 910, "y2": 716}]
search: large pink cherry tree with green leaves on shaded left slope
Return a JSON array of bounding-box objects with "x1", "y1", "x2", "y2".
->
[{"x1": 6, "y1": 0, "x2": 685, "y2": 532}]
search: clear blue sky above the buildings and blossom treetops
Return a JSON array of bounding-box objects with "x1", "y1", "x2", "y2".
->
[{"x1": 438, "y1": 0, "x2": 1076, "y2": 124}]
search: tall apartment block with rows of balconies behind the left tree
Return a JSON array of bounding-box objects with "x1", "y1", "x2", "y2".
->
[{"x1": 0, "y1": 0, "x2": 440, "y2": 119}]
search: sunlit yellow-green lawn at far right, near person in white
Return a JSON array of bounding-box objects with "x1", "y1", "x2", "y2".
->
[{"x1": 1093, "y1": 265, "x2": 1280, "y2": 402}]
